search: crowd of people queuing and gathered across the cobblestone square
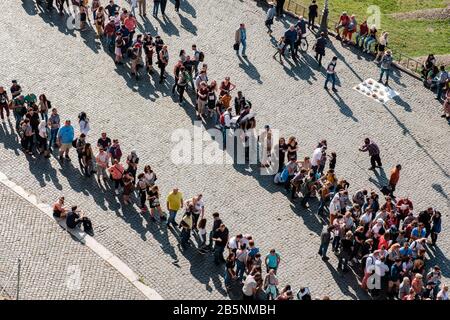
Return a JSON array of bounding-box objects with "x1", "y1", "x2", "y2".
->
[{"x1": 0, "y1": 0, "x2": 448, "y2": 300}]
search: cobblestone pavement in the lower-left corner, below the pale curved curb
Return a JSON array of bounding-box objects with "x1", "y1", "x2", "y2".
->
[{"x1": 0, "y1": 183, "x2": 145, "y2": 300}]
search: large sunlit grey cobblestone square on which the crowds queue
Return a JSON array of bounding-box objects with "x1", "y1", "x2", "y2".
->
[{"x1": 0, "y1": 0, "x2": 450, "y2": 299}]
